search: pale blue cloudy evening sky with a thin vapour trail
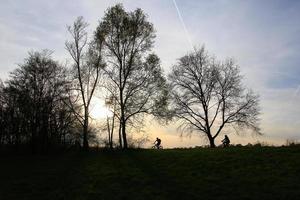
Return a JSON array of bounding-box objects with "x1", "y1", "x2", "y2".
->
[{"x1": 0, "y1": 0, "x2": 300, "y2": 147}]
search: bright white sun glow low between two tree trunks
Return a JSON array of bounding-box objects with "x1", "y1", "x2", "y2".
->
[{"x1": 90, "y1": 97, "x2": 111, "y2": 120}]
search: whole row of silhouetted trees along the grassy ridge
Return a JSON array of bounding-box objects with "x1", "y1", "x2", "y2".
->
[{"x1": 0, "y1": 4, "x2": 259, "y2": 150}]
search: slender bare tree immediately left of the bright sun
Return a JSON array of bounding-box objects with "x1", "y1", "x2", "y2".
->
[{"x1": 66, "y1": 17, "x2": 104, "y2": 150}]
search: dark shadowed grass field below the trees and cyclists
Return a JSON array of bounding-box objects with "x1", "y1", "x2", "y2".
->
[{"x1": 0, "y1": 147, "x2": 300, "y2": 200}]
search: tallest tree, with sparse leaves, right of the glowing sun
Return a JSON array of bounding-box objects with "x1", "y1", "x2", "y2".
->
[{"x1": 95, "y1": 4, "x2": 166, "y2": 149}]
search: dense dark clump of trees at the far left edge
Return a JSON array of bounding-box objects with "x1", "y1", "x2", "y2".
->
[{"x1": 1, "y1": 50, "x2": 76, "y2": 152}]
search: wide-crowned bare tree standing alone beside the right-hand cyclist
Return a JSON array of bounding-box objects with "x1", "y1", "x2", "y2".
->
[{"x1": 169, "y1": 47, "x2": 260, "y2": 147}]
